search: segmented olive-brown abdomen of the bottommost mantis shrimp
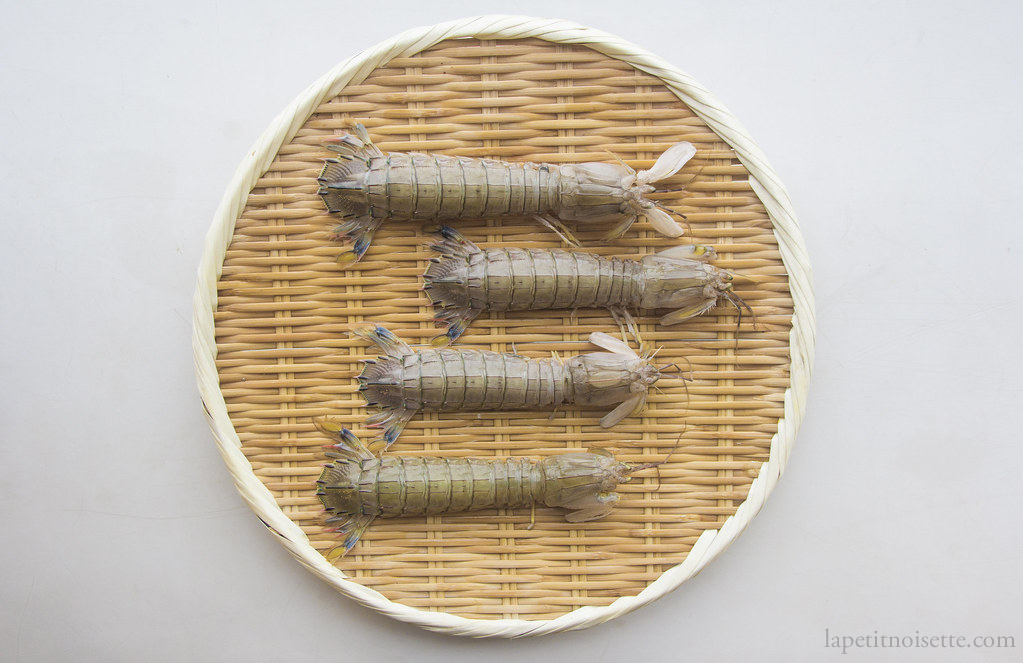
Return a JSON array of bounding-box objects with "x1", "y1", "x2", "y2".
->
[{"x1": 353, "y1": 456, "x2": 542, "y2": 518}]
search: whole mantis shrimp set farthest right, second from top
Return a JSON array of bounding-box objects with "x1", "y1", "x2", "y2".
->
[{"x1": 424, "y1": 226, "x2": 749, "y2": 343}]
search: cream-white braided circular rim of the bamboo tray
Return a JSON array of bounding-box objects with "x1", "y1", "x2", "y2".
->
[{"x1": 192, "y1": 15, "x2": 814, "y2": 637}]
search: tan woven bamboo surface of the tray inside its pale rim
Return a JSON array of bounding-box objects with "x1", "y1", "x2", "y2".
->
[{"x1": 209, "y1": 35, "x2": 793, "y2": 619}]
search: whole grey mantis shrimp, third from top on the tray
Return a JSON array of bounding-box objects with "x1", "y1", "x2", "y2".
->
[{"x1": 353, "y1": 324, "x2": 661, "y2": 446}]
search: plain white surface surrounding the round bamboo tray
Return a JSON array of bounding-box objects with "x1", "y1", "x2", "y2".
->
[{"x1": 0, "y1": 0, "x2": 1023, "y2": 663}]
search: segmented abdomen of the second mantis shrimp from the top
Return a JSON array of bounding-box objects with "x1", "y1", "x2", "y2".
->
[{"x1": 460, "y1": 249, "x2": 642, "y2": 311}]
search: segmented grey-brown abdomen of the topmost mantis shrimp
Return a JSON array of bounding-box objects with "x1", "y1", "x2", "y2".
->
[{"x1": 365, "y1": 152, "x2": 561, "y2": 220}]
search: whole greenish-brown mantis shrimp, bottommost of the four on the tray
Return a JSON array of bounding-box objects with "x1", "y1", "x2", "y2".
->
[{"x1": 316, "y1": 424, "x2": 660, "y2": 557}]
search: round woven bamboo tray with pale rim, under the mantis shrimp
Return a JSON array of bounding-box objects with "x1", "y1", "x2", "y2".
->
[{"x1": 194, "y1": 16, "x2": 813, "y2": 636}]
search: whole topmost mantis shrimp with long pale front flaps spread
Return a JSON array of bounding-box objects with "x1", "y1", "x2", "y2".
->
[{"x1": 317, "y1": 125, "x2": 696, "y2": 265}]
